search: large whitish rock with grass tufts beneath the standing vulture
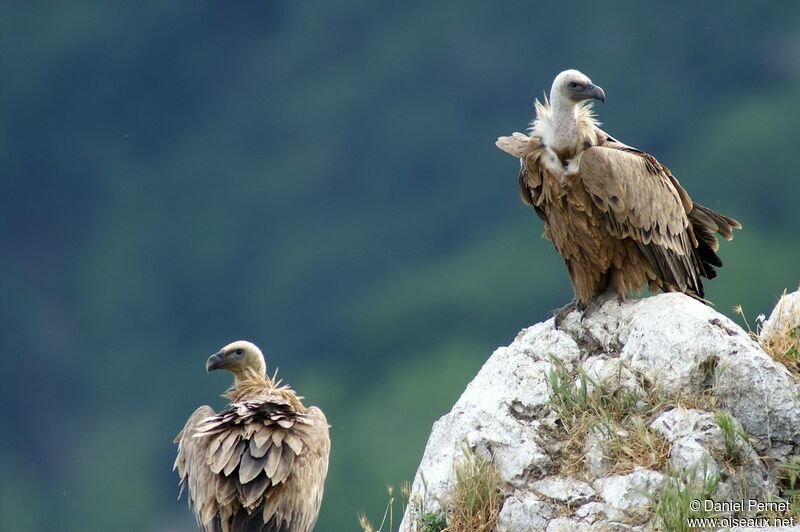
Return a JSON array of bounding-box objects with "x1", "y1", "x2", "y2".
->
[{"x1": 401, "y1": 293, "x2": 800, "y2": 532}]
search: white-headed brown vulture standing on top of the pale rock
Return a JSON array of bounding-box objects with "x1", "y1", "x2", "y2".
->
[{"x1": 497, "y1": 70, "x2": 741, "y2": 308}]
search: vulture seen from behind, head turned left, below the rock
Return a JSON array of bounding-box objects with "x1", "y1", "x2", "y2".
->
[{"x1": 173, "y1": 341, "x2": 331, "y2": 532}]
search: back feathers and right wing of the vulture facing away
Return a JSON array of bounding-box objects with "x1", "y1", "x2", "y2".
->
[{"x1": 191, "y1": 393, "x2": 330, "y2": 531}]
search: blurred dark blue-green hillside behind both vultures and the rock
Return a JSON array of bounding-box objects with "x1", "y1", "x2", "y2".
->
[{"x1": 0, "y1": 0, "x2": 800, "y2": 531}]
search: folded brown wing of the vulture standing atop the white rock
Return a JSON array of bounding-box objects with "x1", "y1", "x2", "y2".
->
[{"x1": 579, "y1": 144, "x2": 708, "y2": 298}]
